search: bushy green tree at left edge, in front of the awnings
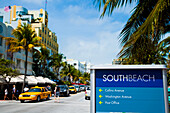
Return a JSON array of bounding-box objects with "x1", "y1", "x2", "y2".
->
[{"x1": 0, "y1": 59, "x2": 18, "y2": 84}]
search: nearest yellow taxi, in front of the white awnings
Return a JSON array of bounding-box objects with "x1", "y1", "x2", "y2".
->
[{"x1": 19, "y1": 86, "x2": 51, "y2": 103}]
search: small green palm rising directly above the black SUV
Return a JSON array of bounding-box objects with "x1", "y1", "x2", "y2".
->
[{"x1": 49, "y1": 54, "x2": 65, "y2": 79}]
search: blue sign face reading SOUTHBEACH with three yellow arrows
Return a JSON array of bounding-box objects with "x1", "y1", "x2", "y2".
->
[{"x1": 95, "y1": 69, "x2": 165, "y2": 113}]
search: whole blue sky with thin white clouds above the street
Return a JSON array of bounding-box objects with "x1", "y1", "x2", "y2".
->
[{"x1": 0, "y1": 0, "x2": 135, "y2": 65}]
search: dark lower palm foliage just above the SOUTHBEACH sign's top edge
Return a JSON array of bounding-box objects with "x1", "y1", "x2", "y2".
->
[{"x1": 119, "y1": 37, "x2": 170, "y2": 64}]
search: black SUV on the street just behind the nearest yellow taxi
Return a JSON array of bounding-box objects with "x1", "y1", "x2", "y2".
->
[{"x1": 57, "y1": 85, "x2": 69, "y2": 96}]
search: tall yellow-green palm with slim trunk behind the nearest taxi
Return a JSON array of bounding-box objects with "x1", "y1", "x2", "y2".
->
[{"x1": 8, "y1": 24, "x2": 42, "y2": 91}]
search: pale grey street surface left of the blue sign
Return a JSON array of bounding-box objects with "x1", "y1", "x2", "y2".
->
[{"x1": 0, "y1": 92, "x2": 90, "y2": 113}]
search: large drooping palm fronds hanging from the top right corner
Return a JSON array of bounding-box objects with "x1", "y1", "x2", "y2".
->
[{"x1": 95, "y1": 0, "x2": 170, "y2": 63}]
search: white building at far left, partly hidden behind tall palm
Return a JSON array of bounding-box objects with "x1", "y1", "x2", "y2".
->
[{"x1": 0, "y1": 22, "x2": 33, "y2": 75}]
